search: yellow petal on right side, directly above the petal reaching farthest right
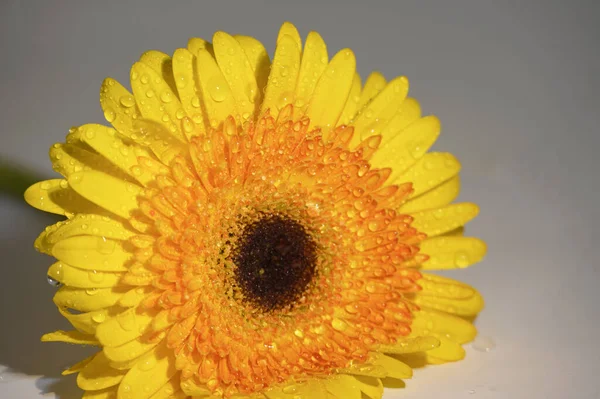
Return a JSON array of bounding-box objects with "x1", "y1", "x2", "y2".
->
[{"x1": 410, "y1": 202, "x2": 479, "y2": 237}]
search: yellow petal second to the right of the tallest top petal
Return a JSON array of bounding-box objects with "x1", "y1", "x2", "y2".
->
[{"x1": 306, "y1": 49, "x2": 356, "y2": 133}]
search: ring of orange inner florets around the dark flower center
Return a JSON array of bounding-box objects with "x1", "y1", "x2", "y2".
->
[{"x1": 123, "y1": 105, "x2": 424, "y2": 395}]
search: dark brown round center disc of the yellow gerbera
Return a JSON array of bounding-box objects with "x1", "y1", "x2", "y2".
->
[{"x1": 233, "y1": 214, "x2": 317, "y2": 312}]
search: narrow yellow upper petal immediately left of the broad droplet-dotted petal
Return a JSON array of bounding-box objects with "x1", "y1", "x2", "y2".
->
[{"x1": 196, "y1": 50, "x2": 238, "y2": 128}]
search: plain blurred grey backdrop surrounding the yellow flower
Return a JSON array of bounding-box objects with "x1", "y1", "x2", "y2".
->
[{"x1": 0, "y1": 0, "x2": 600, "y2": 399}]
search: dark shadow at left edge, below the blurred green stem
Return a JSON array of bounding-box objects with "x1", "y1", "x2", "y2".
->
[{"x1": 0, "y1": 194, "x2": 92, "y2": 399}]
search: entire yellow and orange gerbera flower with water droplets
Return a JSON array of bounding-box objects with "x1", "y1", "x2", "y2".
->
[{"x1": 25, "y1": 23, "x2": 485, "y2": 399}]
